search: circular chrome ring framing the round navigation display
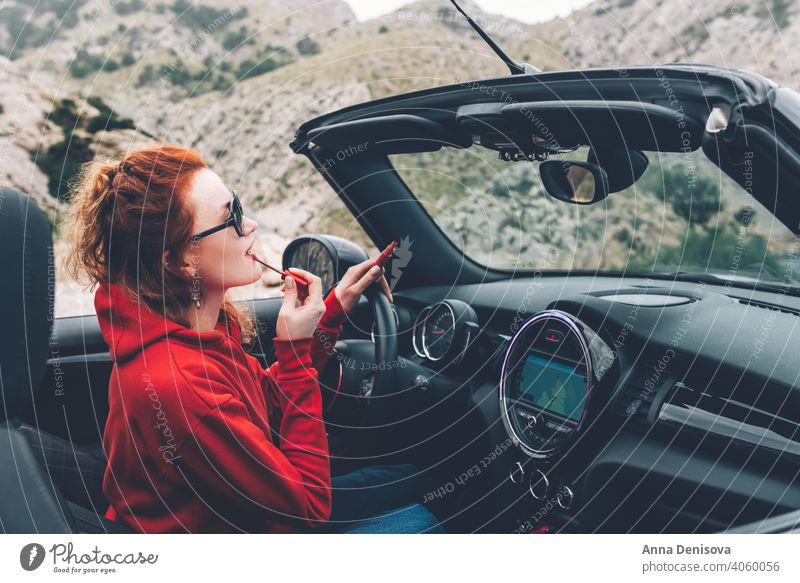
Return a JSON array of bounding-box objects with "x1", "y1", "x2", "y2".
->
[{"x1": 498, "y1": 310, "x2": 594, "y2": 458}]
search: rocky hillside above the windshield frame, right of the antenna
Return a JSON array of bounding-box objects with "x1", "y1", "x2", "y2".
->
[{"x1": 533, "y1": 0, "x2": 800, "y2": 89}]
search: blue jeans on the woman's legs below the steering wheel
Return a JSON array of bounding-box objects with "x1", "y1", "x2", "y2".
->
[{"x1": 310, "y1": 464, "x2": 444, "y2": 534}]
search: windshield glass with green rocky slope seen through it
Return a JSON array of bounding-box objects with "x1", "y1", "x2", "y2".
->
[{"x1": 391, "y1": 146, "x2": 800, "y2": 286}]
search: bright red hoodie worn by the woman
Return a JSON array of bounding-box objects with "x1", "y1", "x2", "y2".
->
[{"x1": 95, "y1": 284, "x2": 346, "y2": 533}]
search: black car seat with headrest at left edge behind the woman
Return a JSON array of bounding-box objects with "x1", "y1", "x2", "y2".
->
[{"x1": 0, "y1": 188, "x2": 131, "y2": 533}]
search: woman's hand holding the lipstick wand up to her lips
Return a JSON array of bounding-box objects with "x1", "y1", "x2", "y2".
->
[{"x1": 276, "y1": 267, "x2": 325, "y2": 340}]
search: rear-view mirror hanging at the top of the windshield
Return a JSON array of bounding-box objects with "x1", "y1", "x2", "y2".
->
[{"x1": 539, "y1": 160, "x2": 608, "y2": 204}]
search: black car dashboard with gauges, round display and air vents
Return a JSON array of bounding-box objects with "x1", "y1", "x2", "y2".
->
[{"x1": 384, "y1": 275, "x2": 800, "y2": 532}]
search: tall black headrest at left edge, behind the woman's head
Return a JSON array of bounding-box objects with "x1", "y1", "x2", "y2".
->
[{"x1": 0, "y1": 188, "x2": 55, "y2": 420}]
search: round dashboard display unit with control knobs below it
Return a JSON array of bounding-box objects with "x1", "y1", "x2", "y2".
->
[{"x1": 498, "y1": 310, "x2": 615, "y2": 532}]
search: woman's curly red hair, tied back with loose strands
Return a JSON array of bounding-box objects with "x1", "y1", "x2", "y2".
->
[{"x1": 65, "y1": 144, "x2": 255, "y2": 344}]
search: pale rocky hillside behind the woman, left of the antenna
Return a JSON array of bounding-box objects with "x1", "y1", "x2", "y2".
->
[{"x1": 0, "y1": 0, "x2": 564, "y2": 314}]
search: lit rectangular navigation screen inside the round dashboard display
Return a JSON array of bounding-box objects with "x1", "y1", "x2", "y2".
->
[{"x1": 520, "y1": 354, "x2": 586, "y2": 421}]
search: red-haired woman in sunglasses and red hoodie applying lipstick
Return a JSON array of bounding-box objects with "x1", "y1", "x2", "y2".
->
[{"x1": 67, "y1": 145, "x2": 440, "y2": 533}]
